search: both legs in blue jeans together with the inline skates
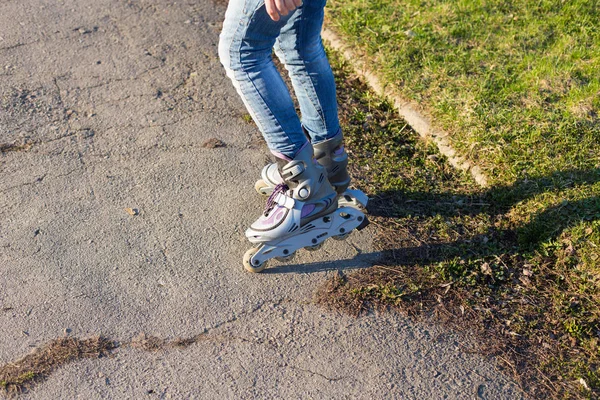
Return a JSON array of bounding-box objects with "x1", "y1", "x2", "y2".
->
[{"x1": 219, "y1": 0, "x2": 367, "y2": 272}]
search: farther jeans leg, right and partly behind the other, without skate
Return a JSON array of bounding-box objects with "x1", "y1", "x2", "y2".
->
[{"x1": 275, "y1": 0, "x2": 340, "y2": 144}]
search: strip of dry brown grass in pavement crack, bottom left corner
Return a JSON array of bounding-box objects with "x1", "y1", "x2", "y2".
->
[{"x1": 0, "y1": 336, "x2": 117, "y2": 395}]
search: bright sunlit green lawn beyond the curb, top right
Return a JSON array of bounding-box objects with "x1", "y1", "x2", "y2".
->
[{"x1": 329, "y1": 0, "x2": 600, "y2": 184}]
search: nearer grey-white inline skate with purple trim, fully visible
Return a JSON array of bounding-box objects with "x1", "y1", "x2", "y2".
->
[{"x1": 244, "y1": 146, "x2": 368, "y2": 272}]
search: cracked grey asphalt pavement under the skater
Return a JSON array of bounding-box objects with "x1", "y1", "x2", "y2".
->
[{"x1": 0, "y1": 0, "x2": 522, "y2": 399}]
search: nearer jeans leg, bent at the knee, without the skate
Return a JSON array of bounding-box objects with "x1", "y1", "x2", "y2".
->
[{"x1": 219, "y1": 0, "x2": 307, "y2": 159}]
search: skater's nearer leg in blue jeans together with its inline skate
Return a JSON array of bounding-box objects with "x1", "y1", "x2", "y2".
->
[{"x1": 219, "y1": 0, "x2": 367, "y2": 272}]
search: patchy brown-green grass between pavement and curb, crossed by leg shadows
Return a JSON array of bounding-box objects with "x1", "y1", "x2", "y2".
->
[{"x1": 324, "y1": 46, "x2": 600, "y2": 398}]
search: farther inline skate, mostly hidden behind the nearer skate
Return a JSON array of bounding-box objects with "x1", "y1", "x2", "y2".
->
[{"x1": 254, "y1": 133, "x2": 369, "y2": 209}]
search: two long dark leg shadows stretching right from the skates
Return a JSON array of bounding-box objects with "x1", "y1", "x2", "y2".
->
[{"x1": 265, "y1": 168, "x2": 600, "y2": 273}]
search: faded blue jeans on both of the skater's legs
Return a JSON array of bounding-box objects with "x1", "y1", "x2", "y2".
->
[{"x1": 219, "y1": 0, "x2": 340, "y2": 159}]
